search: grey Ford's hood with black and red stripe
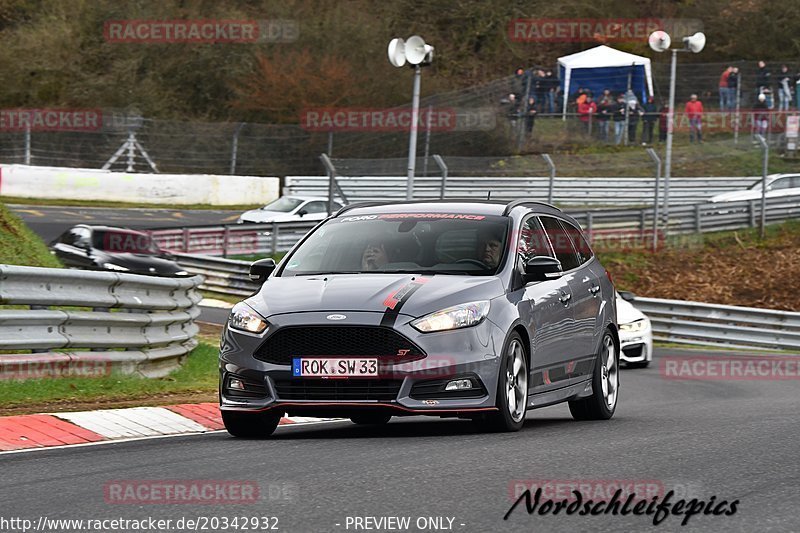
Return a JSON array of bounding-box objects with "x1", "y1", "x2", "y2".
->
[{"x1": 247, "y1": 274, "x2": 504, "y2": 318}]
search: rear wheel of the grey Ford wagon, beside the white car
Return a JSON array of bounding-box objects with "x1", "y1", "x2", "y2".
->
[{"x1": 569, "y1": 330, "x2": 619, "y2": 420}]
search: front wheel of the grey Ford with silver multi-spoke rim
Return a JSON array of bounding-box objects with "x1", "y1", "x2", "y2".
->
[{"x1": 474, "y1": 332, "x2": 528, "y2": 432}]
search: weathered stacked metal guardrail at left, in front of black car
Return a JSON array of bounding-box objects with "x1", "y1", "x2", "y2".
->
[{"x1": 0, "y1": 265, "x2": 202, "y2": 379}]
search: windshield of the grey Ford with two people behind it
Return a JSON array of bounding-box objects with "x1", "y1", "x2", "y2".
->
[{"x1": 278, "y1": 213, "x2": 508, "y2": 276}]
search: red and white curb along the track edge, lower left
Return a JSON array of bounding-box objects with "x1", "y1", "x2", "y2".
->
[{"x1": 0, "y1": 403, "x2": 336, "y2": 452}]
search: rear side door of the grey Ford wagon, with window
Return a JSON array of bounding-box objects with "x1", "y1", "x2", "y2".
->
[{"x1": 559, "y1": 219, "x2": 602, "y2": 357}]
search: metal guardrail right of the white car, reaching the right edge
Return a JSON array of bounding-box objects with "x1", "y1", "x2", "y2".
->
[{"x1": 631, "y1": 296, "x2": 800, "y2": 350}]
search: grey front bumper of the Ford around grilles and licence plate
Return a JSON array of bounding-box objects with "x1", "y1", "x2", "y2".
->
[{"x1": 219, "y1": 312, "x2": 505, "y2": 416}]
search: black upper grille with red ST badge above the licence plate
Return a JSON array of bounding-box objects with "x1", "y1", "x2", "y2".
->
[{"x1": 255, "y1": 326, "x2": 425, "y2": 365}]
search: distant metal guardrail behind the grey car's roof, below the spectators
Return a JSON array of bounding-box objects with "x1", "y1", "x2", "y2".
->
[{"x1": 283, "y1": 175, "x2": 761, "y2": 206}]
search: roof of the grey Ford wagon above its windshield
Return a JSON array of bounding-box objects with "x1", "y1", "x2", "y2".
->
[{"x1": 334, "y1": 199, "x2": 577, "y2": 224}]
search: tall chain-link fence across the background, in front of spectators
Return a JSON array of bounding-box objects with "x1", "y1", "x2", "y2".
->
[{"x1": 0, "y1": 56, "x2": 797, "y2": 176}]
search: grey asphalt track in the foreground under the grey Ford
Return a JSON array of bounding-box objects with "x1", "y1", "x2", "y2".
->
[{"x1": 0, "y1": 348, "x2": 800, "y2": 532}]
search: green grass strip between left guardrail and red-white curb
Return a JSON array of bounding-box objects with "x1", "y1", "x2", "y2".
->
[{"x1": 0, "y1": 342, "x2": 219, "y2": 408}]
